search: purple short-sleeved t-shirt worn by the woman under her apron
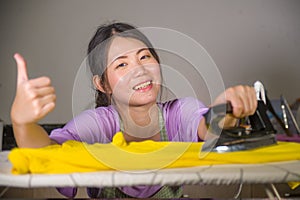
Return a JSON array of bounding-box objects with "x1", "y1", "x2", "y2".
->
[{"x1": 50, "y1": 97, "x2": 208, "y2": 198}]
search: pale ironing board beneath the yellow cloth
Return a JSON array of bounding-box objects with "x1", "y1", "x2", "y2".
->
[{"x1": 0, "y1": 151, "x2": 300, "y2": 188}]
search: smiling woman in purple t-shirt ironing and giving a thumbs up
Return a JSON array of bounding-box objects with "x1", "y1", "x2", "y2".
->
[{"x1": 11, "y1": 23, "x2": 257, "y2": 198}]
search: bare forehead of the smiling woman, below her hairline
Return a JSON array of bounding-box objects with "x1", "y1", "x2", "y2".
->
[{"x1": 108, "y1": 37, "x2": 147, "y2": 62}]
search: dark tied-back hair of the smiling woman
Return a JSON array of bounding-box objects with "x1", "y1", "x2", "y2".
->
[{"x1": 87, "y1": 22, "x2": 160, "y2": 107}]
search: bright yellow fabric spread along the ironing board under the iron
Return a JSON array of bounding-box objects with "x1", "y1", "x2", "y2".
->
[{"x1": 9, "y1": 133, "x2": 300, "y2": 179}]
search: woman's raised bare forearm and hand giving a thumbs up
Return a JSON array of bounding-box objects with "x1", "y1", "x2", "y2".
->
[{"x1": 11, "y1": 54, "x2": 56, "y2": 148}]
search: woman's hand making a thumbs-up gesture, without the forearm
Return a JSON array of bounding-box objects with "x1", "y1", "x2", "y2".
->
[{"x1": 11, "y1": 54, "x2": 56, "y2": 125}]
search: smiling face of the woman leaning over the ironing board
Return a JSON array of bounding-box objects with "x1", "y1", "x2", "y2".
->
[{"x1": 107, "y1": 37, "x2": 161, "y2": 106}]
